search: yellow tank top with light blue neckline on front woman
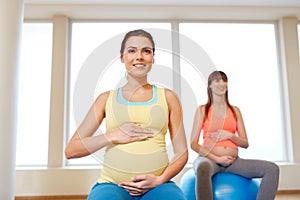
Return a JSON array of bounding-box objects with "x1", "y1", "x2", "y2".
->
[{"x1": 98, "y1": 86, "x2": 169, "y2": 184}]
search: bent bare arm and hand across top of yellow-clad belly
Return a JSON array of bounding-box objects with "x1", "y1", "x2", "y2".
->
[{"x1": 65, "y1": 92, "x2": 153, "y2": 159}]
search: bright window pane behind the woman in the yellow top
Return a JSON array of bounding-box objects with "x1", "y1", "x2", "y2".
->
[{"x1": 67, "y1": 22, "x2": 172, "y2": 165}]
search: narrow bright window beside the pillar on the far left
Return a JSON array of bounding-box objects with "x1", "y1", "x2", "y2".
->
[{"x1": 16, "y1": 23, "x2": 52, "y2": 166}]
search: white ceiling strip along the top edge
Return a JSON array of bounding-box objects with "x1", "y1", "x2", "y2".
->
[{"x1": 24, "y1": 0, "x2": 300, "y2": 7}]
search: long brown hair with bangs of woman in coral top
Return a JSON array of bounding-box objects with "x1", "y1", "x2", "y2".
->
[{"x1": 204, "y1": 71, "x2": 236, "y2": 119}]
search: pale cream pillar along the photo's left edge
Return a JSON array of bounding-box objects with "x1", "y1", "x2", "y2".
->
[{"x1": 0, "y1": 0, "x2": 24, "y2": 199}]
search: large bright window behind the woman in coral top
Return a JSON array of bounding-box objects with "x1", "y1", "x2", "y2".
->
[{"x1": 180, "y1": 23, "x2": 286, "y2": 161}]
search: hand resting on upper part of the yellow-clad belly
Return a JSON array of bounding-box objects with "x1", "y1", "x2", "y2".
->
[{"x1": 105, "y1": 123, "x2": 153, "y2": 144}]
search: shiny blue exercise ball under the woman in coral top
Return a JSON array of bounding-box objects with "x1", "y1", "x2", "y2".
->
[{"x1": 179, "y1": 169, "x2": 260, "y2": 200}]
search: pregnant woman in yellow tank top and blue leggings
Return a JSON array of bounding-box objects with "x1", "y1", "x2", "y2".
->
[{"x1": 65, "y1": 30, "x2": 188, "y2": 200}]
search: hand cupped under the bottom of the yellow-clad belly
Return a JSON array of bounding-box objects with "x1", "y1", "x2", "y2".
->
[{"x1": 119, "y1": 174, "x2": 160, "y2": 196}]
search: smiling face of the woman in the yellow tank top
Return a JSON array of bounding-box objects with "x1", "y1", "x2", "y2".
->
[{"x1": 121, "y1": 36, "x2": 154, "y2": 77}]
